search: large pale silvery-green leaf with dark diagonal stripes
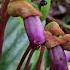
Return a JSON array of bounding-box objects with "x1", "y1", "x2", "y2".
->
[{"x1": 0, "y1": 17, "x2": 29, "y2": 70}]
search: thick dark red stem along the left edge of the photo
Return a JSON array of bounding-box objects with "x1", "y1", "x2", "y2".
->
[{"x1": 0, "y1": 0, "x2": 10, "y2": 54}]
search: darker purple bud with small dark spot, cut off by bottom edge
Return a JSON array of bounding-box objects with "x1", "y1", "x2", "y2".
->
[{"x1": 49, "y1": 46, "x2": 68, "y2": 70}]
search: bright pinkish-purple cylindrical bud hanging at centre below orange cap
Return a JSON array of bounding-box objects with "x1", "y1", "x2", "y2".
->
[{"x1": 25, "y1": 16, "x2": 45, "y2": 45}]
